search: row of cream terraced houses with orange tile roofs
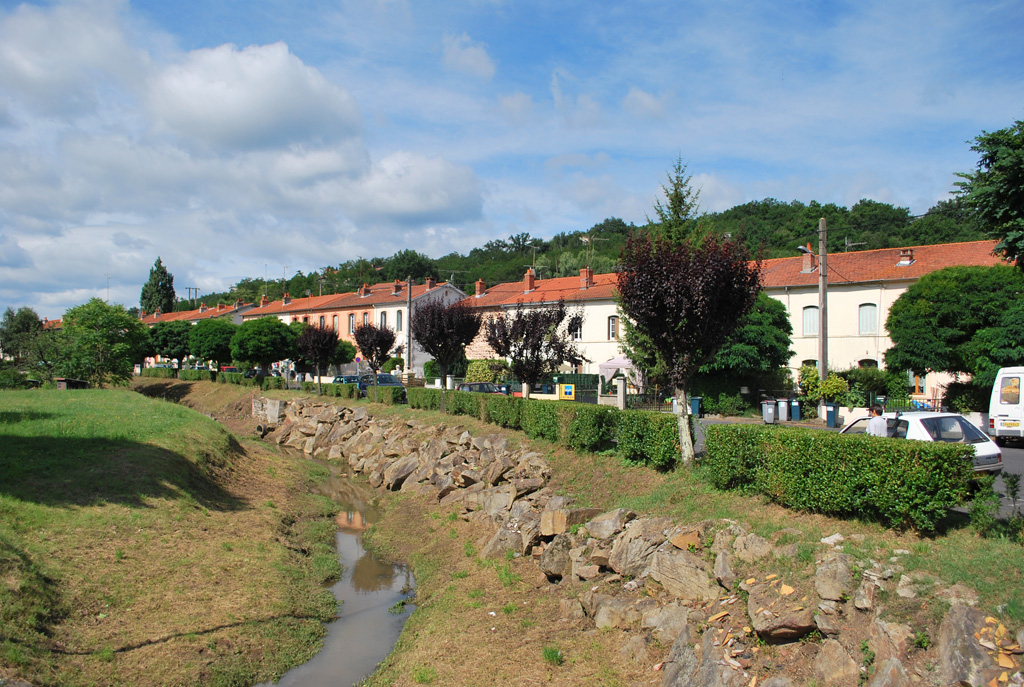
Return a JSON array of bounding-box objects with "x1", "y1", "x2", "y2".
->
[{"x1": 143, "y1": 241, "x2": 1001, "y2": 397}]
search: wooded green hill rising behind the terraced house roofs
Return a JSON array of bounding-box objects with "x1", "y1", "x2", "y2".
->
[{"x1": 177, "y1": 198, "x2": 987, "y2": 310}]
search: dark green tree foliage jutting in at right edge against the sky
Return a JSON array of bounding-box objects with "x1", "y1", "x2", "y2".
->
[{"x1": 956, "y1": 120, "x2": 1024, "y2": 269}]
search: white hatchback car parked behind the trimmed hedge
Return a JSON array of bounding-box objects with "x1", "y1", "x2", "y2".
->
[{"x1": 841, "y1": 412, "x2": 1002, "y2": 474}]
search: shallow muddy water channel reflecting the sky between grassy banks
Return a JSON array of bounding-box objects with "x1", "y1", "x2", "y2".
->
[{"x1": 258, "y1": 464, "x2": 415, "y2": 687}]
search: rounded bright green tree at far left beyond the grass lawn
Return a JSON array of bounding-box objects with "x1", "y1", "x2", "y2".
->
[{"x1": 54, "y1": 298, "x2": 150, "y2": 387}]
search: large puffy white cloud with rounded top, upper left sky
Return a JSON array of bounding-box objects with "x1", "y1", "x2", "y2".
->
[{"x1": 147, "y1": 43, "x2": 361, "y2": 149}]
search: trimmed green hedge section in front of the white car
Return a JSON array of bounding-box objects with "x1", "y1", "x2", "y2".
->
[{"x1": 700, "y1": 425, "x2": 974, "y2": 532}]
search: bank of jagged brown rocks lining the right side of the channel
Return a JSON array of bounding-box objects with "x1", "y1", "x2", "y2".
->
[{"x1": 253, "y1": 398, "x2": 1011, "y2": 687}]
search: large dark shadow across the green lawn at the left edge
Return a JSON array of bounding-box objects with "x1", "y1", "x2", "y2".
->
[{"x1": 0, "y1": 434, "x2": 246, "y2": 511}]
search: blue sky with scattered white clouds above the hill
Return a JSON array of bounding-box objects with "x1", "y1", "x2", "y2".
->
[{"x1": 0, "y1": 0, "x2": 1024, "y2": 318}]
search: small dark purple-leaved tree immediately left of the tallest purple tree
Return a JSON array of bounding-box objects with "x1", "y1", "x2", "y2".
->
[{"x1": 484, "y1": 300, "x2": 587, "y2": 398}]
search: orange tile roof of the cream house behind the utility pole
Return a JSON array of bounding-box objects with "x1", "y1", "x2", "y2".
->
[{"x1": 761, "y1": 241, "x2": 1006, "y2": 289}]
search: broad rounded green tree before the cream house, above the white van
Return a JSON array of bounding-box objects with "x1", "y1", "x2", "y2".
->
[{"x1": 885, "y1": 265, "x2": 1024, "y2": 375}]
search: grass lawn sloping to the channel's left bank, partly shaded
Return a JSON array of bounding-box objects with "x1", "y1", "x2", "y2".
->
[{"x1": 0, "y1": 390, "x2": 338, "y2": 685}]
